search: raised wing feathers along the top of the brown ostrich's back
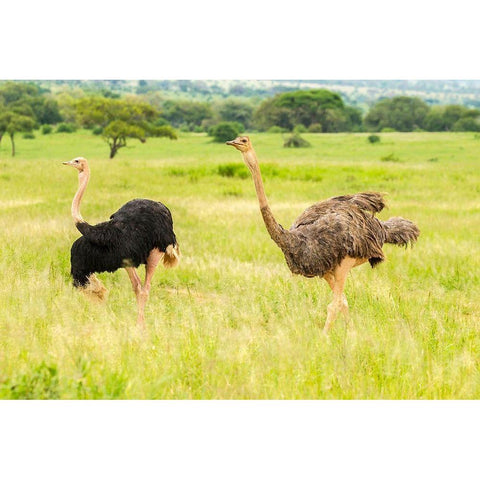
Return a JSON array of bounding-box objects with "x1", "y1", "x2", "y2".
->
[{"x1": 291, "y1": 192, "x2": 385, "y2": 229}]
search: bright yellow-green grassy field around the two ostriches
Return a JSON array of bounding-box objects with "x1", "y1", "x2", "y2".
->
[{"x1": 0, "y1": 131, "x2": 480, "y2": 399}]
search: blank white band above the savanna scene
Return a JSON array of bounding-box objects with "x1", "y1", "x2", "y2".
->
[{"x1": 0, "y1": 0, "x2": 478, "y2": 79}]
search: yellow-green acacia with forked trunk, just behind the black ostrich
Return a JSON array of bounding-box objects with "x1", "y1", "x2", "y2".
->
[{"x1": 76, "y1": 97, "x2": 177, "y2": 158}]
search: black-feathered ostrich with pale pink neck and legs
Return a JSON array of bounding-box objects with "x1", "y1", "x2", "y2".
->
[{"x1": 63, "y1": 157, "x2": 180, "y2": 326}]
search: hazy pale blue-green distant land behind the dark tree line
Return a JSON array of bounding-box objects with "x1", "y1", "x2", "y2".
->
[{"x1": 8, "y1": 80, "x2": 480, "y2": 111}]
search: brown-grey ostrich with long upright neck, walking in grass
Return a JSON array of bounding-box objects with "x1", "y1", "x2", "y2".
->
[{"x1": 227, "y1": 136, "x2": 420, "y2": 333}]
